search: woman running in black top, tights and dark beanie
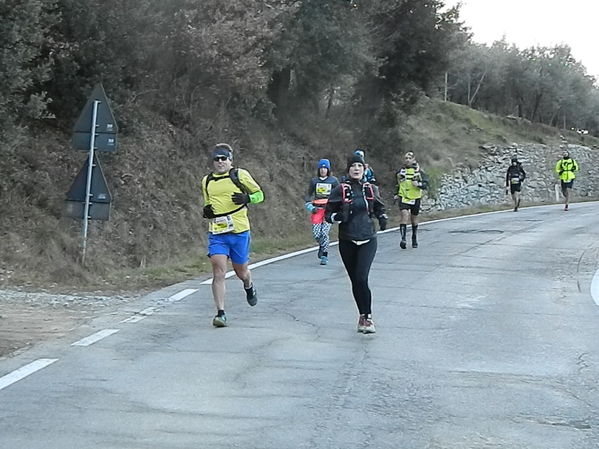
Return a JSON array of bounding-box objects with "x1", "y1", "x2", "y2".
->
[{"x1": 325, "y1": 155, "x2": 387, "y2": 334}]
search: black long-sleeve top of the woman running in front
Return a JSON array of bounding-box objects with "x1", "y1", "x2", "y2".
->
[{"x1": 325, "y1": 179, "x2": 385, "y2": 241}]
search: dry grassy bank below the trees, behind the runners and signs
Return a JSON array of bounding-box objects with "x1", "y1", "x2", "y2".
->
[{"x1": 0, "y1": 100, "x2": 599, "y2": 290}]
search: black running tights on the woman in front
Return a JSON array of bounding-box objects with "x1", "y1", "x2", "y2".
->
[{"x1": 339, "y1": 239, "x2": 377, "y2": 315}]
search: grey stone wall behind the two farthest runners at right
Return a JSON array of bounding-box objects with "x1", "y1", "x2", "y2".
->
[{"x1": 424, "y1": 144, "x2": 599, "y2": 210}]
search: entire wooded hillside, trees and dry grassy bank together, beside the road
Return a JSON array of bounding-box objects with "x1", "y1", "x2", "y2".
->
[{"x1": 0, "y1": 0, "x2": 599, "y2": 288}]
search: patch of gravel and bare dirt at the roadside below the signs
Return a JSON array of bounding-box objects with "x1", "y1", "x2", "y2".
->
[{"x1": 0, "y1": 290, "x2": 143, "y2": 358}]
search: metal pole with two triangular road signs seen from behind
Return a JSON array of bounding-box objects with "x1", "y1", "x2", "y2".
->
[{"x1": 66, "y1": 84, "x2": 118, "y2": 265}]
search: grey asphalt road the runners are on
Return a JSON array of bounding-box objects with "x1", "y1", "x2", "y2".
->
[{"x1": 0, "y1": 203, "x2": 599, "y2": 449}]
